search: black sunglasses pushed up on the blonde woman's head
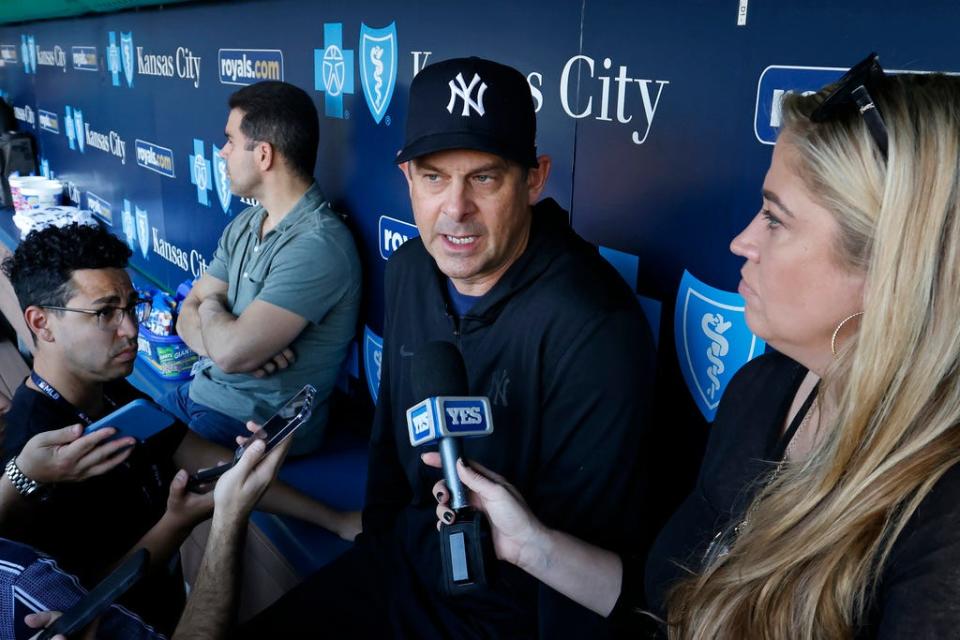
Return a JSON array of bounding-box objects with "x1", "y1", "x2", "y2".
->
[{"x1": 810, "y1": 53, "x2": 888, "y2": 160}]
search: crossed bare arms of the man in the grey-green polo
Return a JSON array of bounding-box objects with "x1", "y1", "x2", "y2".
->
[{"x1": 177, "y1": 274, "x2": 307, "y2": 375}]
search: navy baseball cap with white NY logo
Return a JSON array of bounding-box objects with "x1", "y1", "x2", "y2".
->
[{"x1": 396, "y1": 58, "x2": 537, "y2": 167}]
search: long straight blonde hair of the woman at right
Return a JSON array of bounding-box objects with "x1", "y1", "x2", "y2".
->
[{"x1": 668, "y1": 74, "x2": 960, "y2": 640}]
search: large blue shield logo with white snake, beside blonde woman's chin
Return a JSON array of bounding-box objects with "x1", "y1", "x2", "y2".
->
[{"x1": 674, "y1": 270, "x2": 766, "y2": 422}]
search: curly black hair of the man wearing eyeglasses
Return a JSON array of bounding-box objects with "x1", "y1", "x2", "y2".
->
[{"x1": 3, "y1": 224, "x2": 132, "y2": 311}]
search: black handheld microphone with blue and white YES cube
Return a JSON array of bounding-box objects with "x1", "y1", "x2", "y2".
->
[{"x1": 407, "y1": 341, "x2": 495, "y2": 595}]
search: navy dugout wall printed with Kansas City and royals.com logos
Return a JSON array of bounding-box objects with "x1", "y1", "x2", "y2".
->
[{"x1": 0, "y1": 0, "x2": 948, "y2": 504}]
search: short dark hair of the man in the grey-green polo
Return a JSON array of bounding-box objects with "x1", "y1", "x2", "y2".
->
[{"x1": 229, "y1": 80, "x2": 320, "y2": 180}]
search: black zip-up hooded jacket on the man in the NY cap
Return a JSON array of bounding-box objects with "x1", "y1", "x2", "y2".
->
[{"x1": 363, "y1": 199, "x2": 654, "y2": 637}]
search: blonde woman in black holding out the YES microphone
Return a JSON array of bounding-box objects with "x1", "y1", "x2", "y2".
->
[{"x1": 426, "y1": 55, "x2": 960, "y2": 640}]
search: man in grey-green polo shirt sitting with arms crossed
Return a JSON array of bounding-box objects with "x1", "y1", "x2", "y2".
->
[{"x1": 164, "y1": 82, "x2": 361, "y2": 454}]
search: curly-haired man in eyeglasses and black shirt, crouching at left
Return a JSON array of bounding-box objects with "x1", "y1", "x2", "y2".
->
[{"x1": 3, "y1": 224, "x2": 362, "y2": 632}]
